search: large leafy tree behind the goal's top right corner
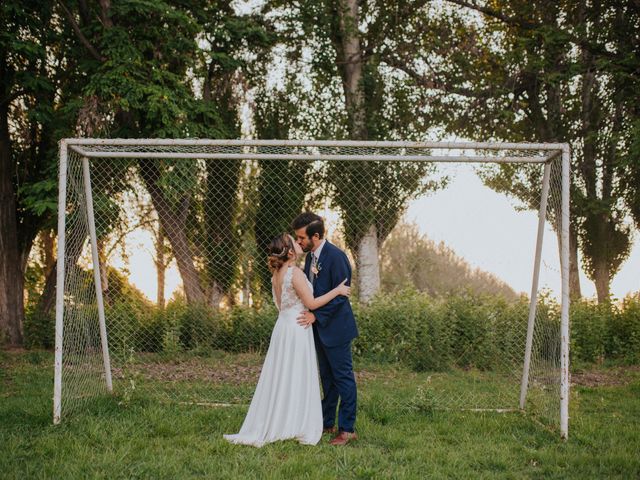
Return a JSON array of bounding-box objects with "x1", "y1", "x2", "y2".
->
[{"x1": 385, "y1": 0, "x2": 637, "y2": 301}]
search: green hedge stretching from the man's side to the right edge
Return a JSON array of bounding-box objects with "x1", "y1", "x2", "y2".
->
[{"x1": 354, "y1": 290, "x2": 640, "y2": 371}]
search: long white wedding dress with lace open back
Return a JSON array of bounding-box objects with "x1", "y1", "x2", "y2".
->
[{"x1": 224, "y1": 267, "x2": 322, "y2": 447}]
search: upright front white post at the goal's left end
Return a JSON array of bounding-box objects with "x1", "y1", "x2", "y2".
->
[{"x1": 53, "y1": 140, "x2": 67, "y2": 425}]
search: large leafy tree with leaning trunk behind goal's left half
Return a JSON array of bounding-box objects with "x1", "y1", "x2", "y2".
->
[{"x1": 55, "y1": 1, "x2": 272, "y2": 305}]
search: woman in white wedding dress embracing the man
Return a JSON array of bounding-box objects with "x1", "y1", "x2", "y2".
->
[{"x1": 224, "y1": 233, "x2": 351, "y2": 447}]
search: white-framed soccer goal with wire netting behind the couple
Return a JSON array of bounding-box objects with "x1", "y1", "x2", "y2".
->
[{"x1": 54, "y1": 139, "x2": 570, "y2": 438}]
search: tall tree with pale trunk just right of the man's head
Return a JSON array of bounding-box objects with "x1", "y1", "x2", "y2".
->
[{"x1": 270, "y1": 0, "x2": 438, "y2": 302}]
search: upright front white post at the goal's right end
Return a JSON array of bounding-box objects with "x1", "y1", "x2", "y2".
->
[{"x1": 560, "y1": 144, "x2": 571, "y2": 439}]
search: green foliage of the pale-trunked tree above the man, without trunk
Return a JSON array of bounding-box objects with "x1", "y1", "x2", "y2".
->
[{"x1": 267, "y1": 1, "x2": 450, "y2": 258}]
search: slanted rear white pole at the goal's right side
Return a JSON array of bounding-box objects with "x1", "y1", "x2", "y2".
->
[{"x1": 520, "y1": 163, "x2": 551, "y2": 409}]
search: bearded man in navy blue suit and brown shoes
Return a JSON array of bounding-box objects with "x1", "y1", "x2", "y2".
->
[{"x1": 293, "y1": 212, "x2": 358, "y2": 445}]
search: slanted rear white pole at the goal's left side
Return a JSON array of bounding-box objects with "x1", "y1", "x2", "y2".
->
[{"x1": 82, "y1": 157, "x2": 113, "y2": 393}]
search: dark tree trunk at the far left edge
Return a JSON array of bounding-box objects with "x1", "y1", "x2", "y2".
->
[{"x1": 0, "y1": 91, "x2": 24, "y2": 347}]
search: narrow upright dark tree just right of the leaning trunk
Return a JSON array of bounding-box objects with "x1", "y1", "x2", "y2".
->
[{"x1": 201, "y1": 2, "x2": 272, "y2": 304}]
